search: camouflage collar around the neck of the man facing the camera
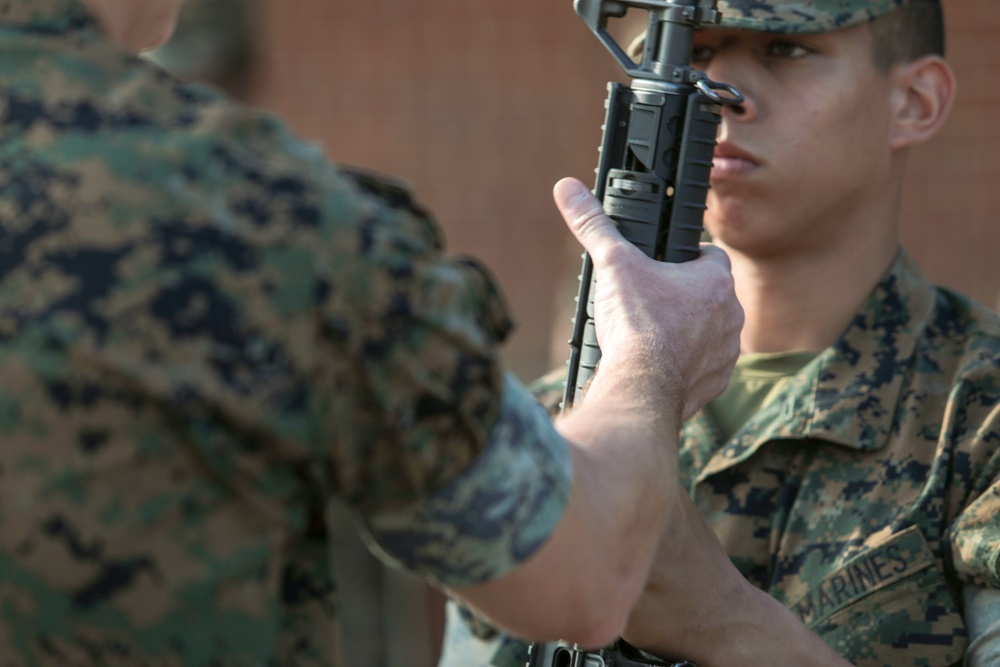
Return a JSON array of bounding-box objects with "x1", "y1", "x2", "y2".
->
[{"x1": 685, "y1": 249, "x2": 935, "y2": 477}]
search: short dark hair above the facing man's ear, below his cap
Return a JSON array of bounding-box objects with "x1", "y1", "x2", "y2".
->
[{"x1": 869, "y1": 0, "x2": 944, "y2": 72}]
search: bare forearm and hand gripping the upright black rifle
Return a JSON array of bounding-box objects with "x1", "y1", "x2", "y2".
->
[{"x1": 454, "y1": 179, "x2": 743, "y2": 646}]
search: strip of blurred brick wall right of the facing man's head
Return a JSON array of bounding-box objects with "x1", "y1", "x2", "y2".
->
[{"x1": 902, "y1": 0, "x2": 1000, "y2": 309}]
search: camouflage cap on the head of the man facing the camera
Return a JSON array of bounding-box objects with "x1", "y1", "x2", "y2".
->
[{"x1": 718, "y1": 0, "x2": 907, "y2": 34}]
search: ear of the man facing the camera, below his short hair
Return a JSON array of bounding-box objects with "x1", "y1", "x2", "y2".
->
[{"x1": 889, "y1": 55, "x2": 956, "y2": 149}]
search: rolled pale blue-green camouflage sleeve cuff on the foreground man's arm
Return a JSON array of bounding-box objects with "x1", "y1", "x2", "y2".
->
[{"x1": 362, "y1": 375, "x2": 572, "y2": 586}]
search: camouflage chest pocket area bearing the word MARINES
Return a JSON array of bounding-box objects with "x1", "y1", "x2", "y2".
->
[{"x1": 789, "y1": 526, "x2": 968, "y2": 667}]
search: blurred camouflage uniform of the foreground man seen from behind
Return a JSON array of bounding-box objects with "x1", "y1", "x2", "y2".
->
[{"x1": 0, "y1": 0, "x2": 570, "y2": 667}]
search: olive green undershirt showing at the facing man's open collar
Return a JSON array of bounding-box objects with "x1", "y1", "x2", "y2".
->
[{"x1": 708, "y1": 352, "x2": 817, "y2": 441}]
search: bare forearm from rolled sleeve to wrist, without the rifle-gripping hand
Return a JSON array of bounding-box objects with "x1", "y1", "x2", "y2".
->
[{"x1": 456, "y1": 374, "x2": 679, "y2": 646}]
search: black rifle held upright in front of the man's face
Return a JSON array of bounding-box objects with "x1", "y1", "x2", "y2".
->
[{"x1": 527, "y1": 0, "x2": 743, "y2": 667}]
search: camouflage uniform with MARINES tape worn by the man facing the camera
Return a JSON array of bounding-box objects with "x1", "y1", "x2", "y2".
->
[{"x1": 448, "y1": 251, "x2": 1000, "y2": 667}]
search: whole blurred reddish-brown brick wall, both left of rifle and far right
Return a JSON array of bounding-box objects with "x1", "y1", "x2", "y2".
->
[{"x1": 242, "y1": 0, "x2": 1000, "y2": 379}]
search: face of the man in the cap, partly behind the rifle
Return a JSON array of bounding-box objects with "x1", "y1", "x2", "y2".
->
[{"x1": 693, "y1": 25, "x2": 891, "y2": 254}]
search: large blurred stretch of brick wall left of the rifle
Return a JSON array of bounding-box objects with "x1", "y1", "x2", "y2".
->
[{"x1": 251, "y1": 0, "x2": 618, "y2": 378}]
